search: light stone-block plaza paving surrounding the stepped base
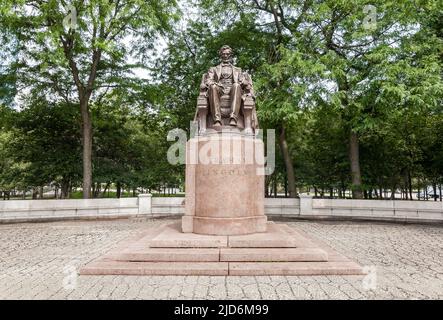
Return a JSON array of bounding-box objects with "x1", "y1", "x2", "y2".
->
[{"x1": 0, "y1": 219, "x2": 443, "y2": 299}]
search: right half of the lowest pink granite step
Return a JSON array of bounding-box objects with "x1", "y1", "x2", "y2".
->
[{"x1": 229, "y1": 262, "x2": 364, "y2": 276}]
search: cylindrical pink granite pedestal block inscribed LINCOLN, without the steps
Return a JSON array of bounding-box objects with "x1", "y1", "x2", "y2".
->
[{"x1": 183, "y1": 134, "x2": 266, "y2": 235}]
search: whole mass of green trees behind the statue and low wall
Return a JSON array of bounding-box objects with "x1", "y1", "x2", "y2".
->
[{"x1": 0, "y1": 0, "x2": 443, "y2": 199}]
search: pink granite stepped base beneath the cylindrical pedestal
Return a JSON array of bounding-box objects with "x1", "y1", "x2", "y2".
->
[{"x1": 80, "y1": 222, "x2": 364, "y2": 276}]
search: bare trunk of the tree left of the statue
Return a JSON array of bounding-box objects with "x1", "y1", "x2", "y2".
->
[{"x1": 80, "y1": 98, "x2": 92, "y2": 199}]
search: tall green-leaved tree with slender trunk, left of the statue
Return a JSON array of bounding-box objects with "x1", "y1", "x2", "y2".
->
[{"x1": 0, "y1": 0, "x2": 177, "y2": 198}]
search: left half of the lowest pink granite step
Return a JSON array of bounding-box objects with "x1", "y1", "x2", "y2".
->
[{"x1": 80, "y1": 261, "x2": 229, "y2": 276}]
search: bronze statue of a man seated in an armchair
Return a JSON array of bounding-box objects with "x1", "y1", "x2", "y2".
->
[{"x1": 194, "y1": 46, "x2": 258, "y2": 134}]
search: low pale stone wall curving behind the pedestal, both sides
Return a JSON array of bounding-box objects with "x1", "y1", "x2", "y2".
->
[{"x1": 0, "y1": 194, "x2": 443, "y2": 223}]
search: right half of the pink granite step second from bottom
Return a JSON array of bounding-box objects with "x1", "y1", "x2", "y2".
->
[{"x1": 220, "y1": 248, "x2": 328, "y2": 262}]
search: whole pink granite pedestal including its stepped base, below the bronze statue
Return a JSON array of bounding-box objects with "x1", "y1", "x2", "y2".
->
[{"x1": 80, "y1": 129, "x2": 363, "y2": 276}]
